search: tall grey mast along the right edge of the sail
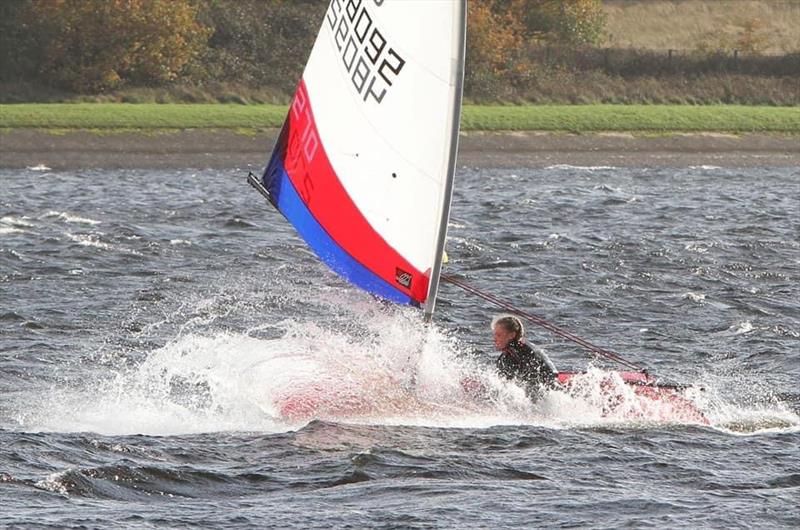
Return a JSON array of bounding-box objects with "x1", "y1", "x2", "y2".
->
[{"x1": 425, "y1": 0, "x2": 467, "y2": 322}]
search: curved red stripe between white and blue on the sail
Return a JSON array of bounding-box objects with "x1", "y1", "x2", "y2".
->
[{"x1": 283, "y1": 80, "x2": 430, "y2": 303}]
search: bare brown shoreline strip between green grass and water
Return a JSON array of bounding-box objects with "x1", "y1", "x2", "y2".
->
[{"x1": 0, "y1": 129, "x2": 800, "y2": 171}]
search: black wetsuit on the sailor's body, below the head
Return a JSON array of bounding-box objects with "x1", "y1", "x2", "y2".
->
[{"x1": 497, "y1": 340, "x2": 557, "y2": 398}]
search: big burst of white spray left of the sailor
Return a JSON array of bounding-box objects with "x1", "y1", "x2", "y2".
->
[{"x1": 20, "y1": 304, "x2": 536, "y2": 435}]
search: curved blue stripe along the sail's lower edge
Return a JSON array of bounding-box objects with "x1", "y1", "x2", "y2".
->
[{"x1": 263, "y1": 160, "x2": 419, "y2": 306}]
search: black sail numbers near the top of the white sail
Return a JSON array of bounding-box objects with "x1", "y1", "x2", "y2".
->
[{"x1": 325, "y1": 0, "x2": 406, "y2": 103}]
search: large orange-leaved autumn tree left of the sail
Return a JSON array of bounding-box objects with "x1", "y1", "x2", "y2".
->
[{"x1": 23, "y1": 0, "x2": 211, "y2": 92}]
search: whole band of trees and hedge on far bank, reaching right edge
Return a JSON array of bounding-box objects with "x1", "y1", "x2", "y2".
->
[{"x1": 0, "y1": 0, "x2": 800, "y2": 105}]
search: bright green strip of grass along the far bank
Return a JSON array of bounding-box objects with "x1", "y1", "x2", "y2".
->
[{"x1": 0, "y1": 103, "x2": 800, "y2": 134}]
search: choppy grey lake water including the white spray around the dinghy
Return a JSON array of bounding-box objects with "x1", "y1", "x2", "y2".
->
[{"x1": 0, "y1": 166, "x2": 800, "y2": 528}]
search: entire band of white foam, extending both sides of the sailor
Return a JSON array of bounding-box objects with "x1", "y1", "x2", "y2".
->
[{"x1": 18, "y1": 290, "x2": 800, "y2": 435}]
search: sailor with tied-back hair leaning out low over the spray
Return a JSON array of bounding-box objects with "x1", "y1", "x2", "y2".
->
[{"x1": 492, "y1": 315, "x2": 558, "y2": 400}]
